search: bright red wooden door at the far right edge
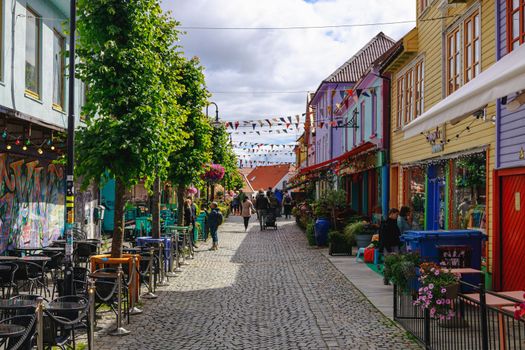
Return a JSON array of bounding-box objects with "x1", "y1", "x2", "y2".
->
[{"x1": 500, "y1": 175, "x2": 525, "y2": 290}]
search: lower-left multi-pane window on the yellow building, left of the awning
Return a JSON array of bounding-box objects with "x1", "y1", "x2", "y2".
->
[{"x1": 396, "y1": 60, "x2": 425, "y2": 128}]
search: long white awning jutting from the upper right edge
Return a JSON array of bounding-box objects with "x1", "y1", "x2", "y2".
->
[{"x1": 403, "y1": 45, "x2": 525, "y2": 139}]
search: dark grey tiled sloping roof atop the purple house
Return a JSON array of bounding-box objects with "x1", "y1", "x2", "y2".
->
[{"x1": 323, "y1": 32, "x2": 395, "y2": 83}]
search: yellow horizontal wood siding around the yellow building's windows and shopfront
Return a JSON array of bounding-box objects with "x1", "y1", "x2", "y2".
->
[{"x1": 391, "y1": 0, "x2": 496, "y2": 266}]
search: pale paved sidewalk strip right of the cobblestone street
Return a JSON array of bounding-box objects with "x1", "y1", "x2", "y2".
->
[{"x1": 322, "y1": 249, "x2": 394, "y2": 320}]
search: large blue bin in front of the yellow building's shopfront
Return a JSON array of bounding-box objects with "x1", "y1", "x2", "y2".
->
[{"x1": 401, "y1": 230, "x2": 487, "y2": 285}]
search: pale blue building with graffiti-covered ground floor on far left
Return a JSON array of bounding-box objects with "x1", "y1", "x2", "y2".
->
[{"x1": 0, "y1": 0, "x2": 92, "y2": 251}]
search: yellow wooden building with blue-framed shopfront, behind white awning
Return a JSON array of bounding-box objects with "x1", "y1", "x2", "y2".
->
[{"x1": 383, "y1": 0, "x2": 496, "y2": 278}]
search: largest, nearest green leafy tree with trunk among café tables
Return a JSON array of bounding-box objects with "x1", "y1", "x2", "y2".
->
[{"x1": 75, "y1": 0, "x2": 185, "y2": 257}]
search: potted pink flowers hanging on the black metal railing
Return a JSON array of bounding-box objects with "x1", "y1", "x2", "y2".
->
[{"x1": 414, "y1": 263, "x2": 459, "y2": 321}]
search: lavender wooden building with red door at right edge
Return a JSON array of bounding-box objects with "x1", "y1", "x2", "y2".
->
[{"x1": 493, "y1": 0, "x2": 525, "y2": 290}]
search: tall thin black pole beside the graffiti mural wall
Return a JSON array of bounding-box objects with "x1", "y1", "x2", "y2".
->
[{"x1": 64, "y1": 0, "x2": 77, "y2": 295}]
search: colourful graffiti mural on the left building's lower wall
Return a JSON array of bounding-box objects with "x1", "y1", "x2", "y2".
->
[{"x1": 0, "y1": 153, "x2": 65, "y2": 252}]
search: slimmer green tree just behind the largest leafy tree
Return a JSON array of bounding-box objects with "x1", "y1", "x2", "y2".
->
[{"x1": 168, "y1": 57, "x2": 212, "y2": 224}]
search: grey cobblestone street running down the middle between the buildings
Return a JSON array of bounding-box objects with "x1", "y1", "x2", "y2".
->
[{"x1": 96, "y1": 217, "x2": 420, "y2": 350}]
